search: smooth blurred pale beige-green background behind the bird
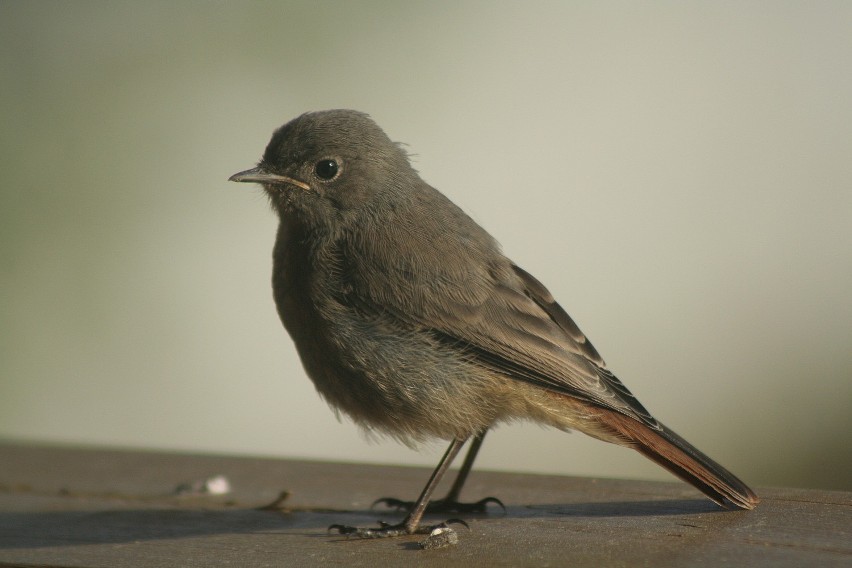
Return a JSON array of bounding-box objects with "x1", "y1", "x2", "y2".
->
[{"x1": 0, "y1": 0, "x2": 852, "y2": 490}]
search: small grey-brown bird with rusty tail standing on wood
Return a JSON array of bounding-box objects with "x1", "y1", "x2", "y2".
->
[{"x1": 230, "y1": 110, "x2": 758, "y2": 537}]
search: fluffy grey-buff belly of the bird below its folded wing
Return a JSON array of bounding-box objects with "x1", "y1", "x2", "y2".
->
[{"x1": 276, "y1": 288, "x2": 517, "y2": 443}]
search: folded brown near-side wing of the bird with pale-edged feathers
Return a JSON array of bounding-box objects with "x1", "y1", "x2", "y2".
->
[{"x1": 348, "y1": 225, "x2": 659, "y2": 428}]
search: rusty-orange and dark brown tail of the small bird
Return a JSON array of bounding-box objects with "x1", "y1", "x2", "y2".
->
[{"x1": 607, "y1": 412, "x2": 760, "y2": 509}]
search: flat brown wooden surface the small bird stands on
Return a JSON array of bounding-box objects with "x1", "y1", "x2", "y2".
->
[{"x1": 0, "y1": 444, "x2": 852, "y2": 568}]
